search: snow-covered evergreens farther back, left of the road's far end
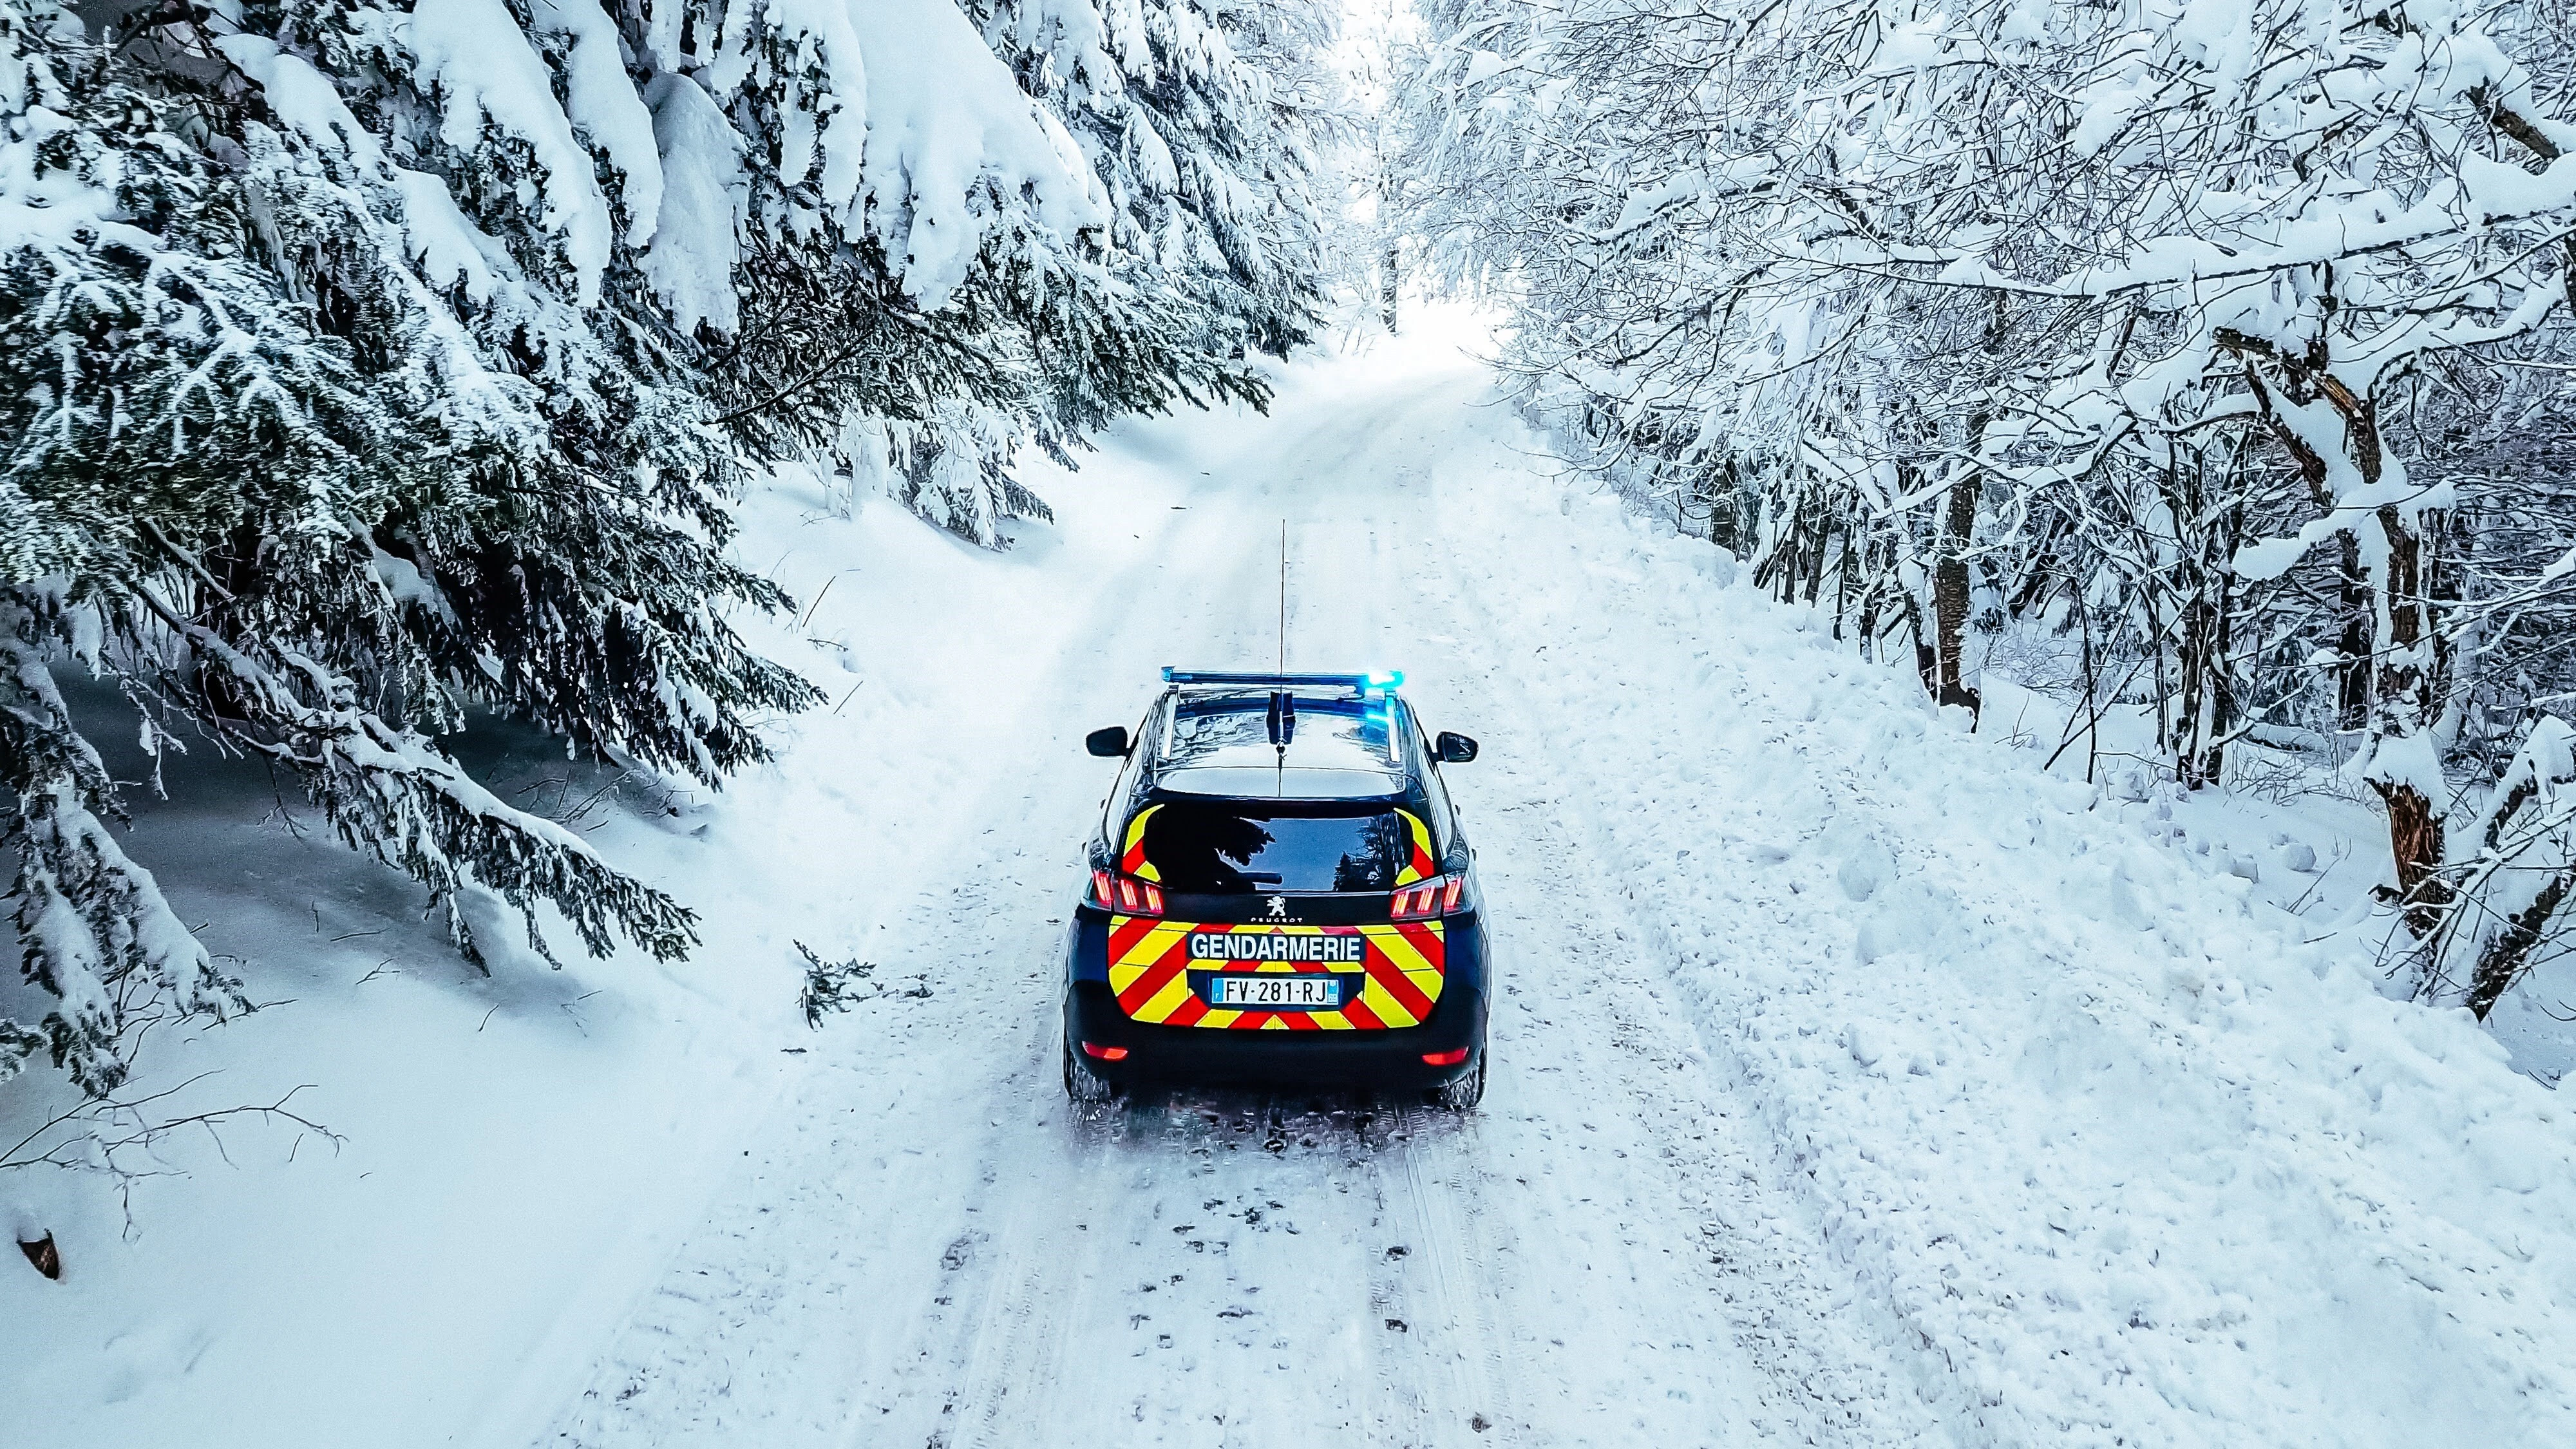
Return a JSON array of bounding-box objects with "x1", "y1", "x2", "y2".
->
[{"x1": 711, "y1": 0, "x2": 1329, "y2": 544}]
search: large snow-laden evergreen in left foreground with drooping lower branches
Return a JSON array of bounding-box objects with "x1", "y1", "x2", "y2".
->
[{"x1": 0, "y1": 0, "x2": 783, "y2": 1094}]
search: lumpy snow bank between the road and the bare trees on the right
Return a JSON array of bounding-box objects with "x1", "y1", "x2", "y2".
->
[{"x1": 1443, "y1": 461, "x2": 2576, "y2": 1446}]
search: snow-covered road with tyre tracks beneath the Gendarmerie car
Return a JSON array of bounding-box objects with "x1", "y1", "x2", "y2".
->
[{"x1": 538, "y1": 350, "x2": 1919, "y2": 1449}]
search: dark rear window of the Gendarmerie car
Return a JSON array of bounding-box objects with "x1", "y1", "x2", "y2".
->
[{"x1": 1144, "y1": 799, "x2": 1404, "y2": 895}]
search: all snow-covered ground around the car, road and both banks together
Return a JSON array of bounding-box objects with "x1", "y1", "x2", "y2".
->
[{"x1": 0, "y1": 316, "x2": 2576, "y2": 1449}]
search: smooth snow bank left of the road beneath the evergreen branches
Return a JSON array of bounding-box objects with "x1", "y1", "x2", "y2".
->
[{"x1": 0, "y1": 448, "x2": 1128, "y2": 1449}]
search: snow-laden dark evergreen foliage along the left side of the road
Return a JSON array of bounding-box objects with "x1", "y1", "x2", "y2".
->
[{"x1": 0, "y1": 0, "x2": 1329, "y2": 1094}]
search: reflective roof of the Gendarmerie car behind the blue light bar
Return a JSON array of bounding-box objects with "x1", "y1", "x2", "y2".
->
[{"x1": 1154, "y1": 688, "x2": 1414, "y2": 799}]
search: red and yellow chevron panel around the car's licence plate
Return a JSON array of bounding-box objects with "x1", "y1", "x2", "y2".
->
[{"x1": 1110, "y1": 915, "x2": 1448, "y2": 1031}]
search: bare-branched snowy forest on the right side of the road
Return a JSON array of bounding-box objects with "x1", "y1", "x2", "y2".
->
[{"x1": 1388, "y1": 0, "x2": 2576, "y2": 1016}]
